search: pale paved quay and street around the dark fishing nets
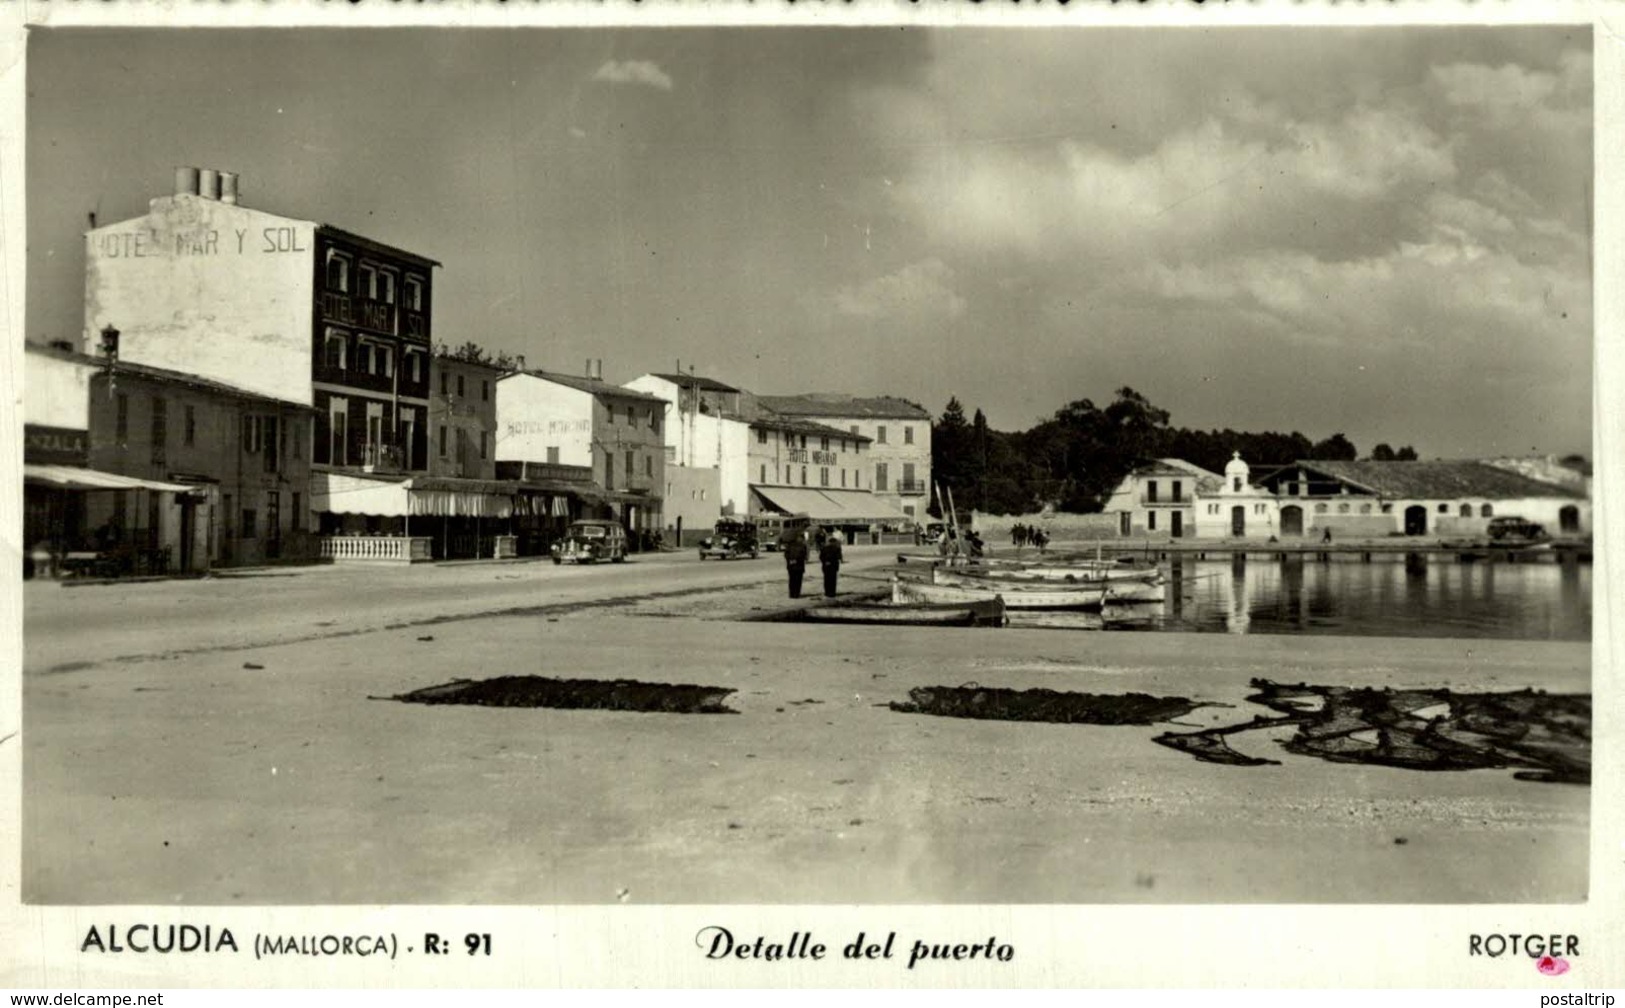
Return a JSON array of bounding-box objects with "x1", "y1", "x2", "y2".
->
[{"x1": 23, "y1": 550, "x2": 1591, "y2": 904}]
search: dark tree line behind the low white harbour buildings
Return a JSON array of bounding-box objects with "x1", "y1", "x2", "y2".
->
[{"x1": 931, "y1": 387, "x2": 1417, "y2": 514}]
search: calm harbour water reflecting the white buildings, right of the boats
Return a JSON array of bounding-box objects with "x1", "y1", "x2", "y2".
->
[{"x1": 1011, "y1": 556, "x2": 1591, "y2": 641}]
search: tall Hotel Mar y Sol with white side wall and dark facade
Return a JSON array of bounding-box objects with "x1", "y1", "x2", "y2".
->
[{"x1": 85, "y1": 167, "x2": 559, "y2": 559}]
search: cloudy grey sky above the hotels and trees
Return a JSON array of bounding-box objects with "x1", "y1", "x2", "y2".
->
[{"x1": 26, "y1": 26, "x2": 1593, "y2": 457}]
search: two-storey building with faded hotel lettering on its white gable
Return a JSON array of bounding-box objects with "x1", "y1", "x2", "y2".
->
[{"x1": 496, "y1": 357, "x2": 668, "y2": 543}]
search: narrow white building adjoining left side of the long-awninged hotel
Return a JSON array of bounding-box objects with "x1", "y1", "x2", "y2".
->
[{"x1": 626, "y1": 372, "x2": 756, "y2": 546}]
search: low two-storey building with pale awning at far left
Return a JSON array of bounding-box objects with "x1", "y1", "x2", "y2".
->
[{"x1": 24, "y1": 345, "x2": 315, "y2": 574}]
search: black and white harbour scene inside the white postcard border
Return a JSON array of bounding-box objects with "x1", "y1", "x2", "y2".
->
[{"x1": 5, "y1": 1, "x2": 1617, "y2": 985}]
